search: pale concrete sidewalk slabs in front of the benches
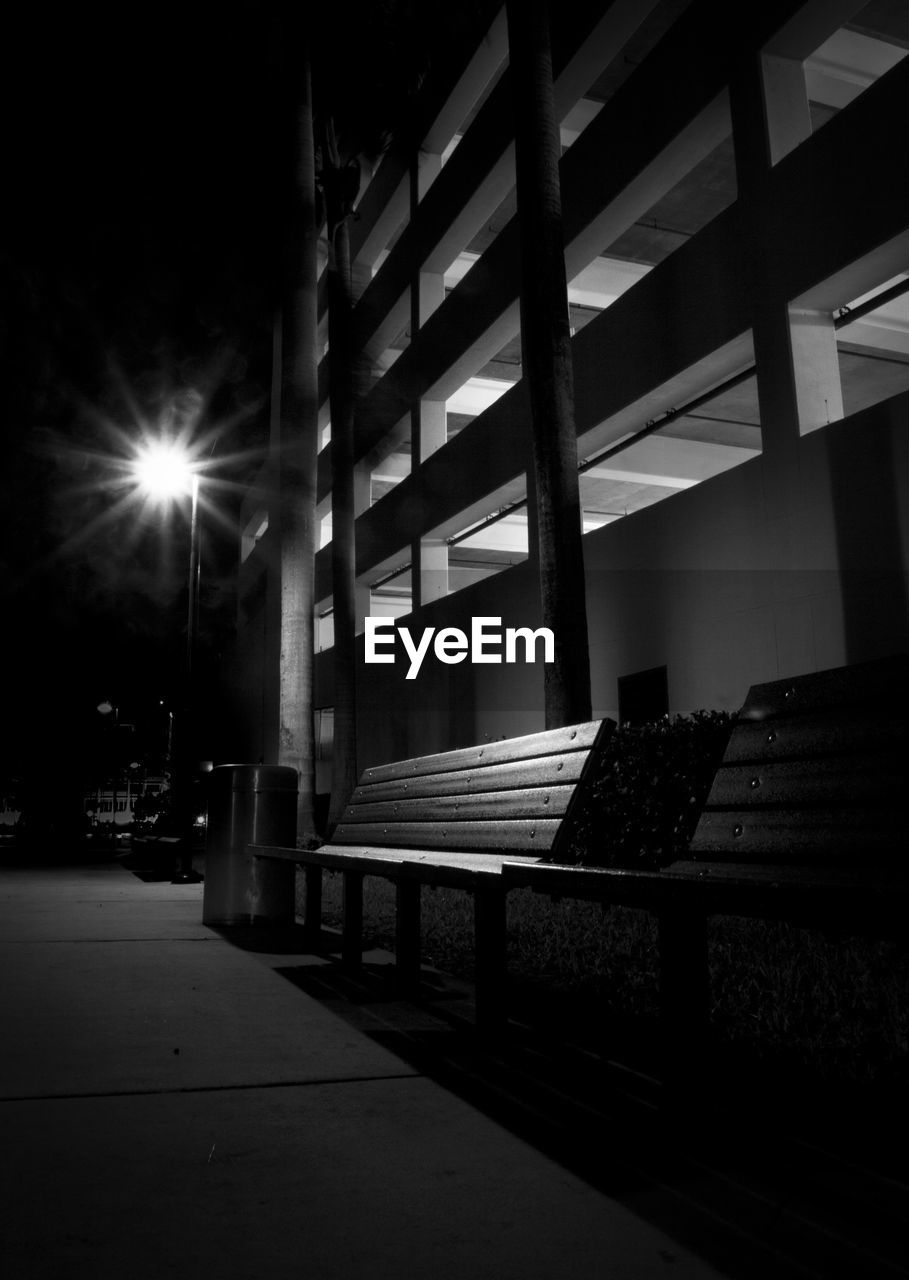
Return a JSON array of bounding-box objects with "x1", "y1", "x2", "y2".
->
[{"x1": 0, "y1": 861, "x2": 720, "y2": 1280}]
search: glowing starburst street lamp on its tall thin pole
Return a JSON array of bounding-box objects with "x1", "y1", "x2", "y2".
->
[{"x1": 132, "y1": 440, "x2": 202, "y2": 884}]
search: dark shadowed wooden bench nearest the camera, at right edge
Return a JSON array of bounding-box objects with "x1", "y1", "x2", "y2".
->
[{"x1": 502, "y1": 657, "x2": 909, "y2": 1066}]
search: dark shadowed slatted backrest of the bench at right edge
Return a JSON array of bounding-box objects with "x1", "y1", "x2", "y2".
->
[{"x1": 686, "y1": 657, "x2": 909, "y2": 878}]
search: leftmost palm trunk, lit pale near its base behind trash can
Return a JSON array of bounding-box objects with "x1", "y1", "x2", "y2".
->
[{"x1": 278, "y1": 32, "x2": 319, "y2": 846}]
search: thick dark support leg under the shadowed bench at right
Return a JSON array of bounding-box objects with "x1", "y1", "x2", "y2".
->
[{"x1": 659, "y1": 911, "x2": 709, "y2": 1094}]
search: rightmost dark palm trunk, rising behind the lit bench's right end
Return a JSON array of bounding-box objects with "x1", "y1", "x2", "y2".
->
[{"x1": 506, "y1": 0, "x2": 590, "y2": 728}]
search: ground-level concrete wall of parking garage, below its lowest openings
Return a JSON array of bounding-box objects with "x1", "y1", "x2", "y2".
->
[{"x1": 309, "y1": 396, "x2": 909, "y2": 768}]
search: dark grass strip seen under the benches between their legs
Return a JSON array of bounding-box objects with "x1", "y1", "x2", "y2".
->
[{"x1": 298, "y1": 872, "x2": 909, "y2": 1085}]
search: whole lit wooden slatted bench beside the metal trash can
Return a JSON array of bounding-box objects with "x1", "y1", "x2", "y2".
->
[{"x1": 251, "y1": 719, "x2": 615, "y2": 1028}]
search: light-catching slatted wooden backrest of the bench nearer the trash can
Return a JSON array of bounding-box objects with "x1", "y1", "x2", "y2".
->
[{"x1": 332, "y1": 719, "x2": 615, "y2": 855}]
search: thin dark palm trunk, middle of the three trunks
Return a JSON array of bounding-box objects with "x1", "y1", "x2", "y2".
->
[{"x1": 325, "y1": 208, "x2": 357, "y2": 829}]
